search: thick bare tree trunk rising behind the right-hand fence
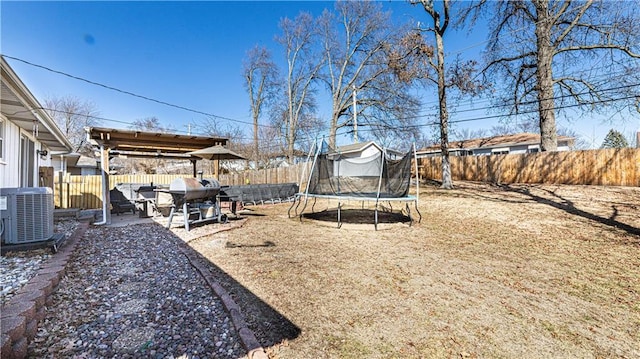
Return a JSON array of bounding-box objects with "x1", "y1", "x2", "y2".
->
[{"x1": 534, "y1": 0, "x2": 558, "y2": 151}]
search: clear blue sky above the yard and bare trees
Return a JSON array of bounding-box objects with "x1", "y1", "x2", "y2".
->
[{"x1": 0, "y1": 1, "x2": 640, "y2": 146}]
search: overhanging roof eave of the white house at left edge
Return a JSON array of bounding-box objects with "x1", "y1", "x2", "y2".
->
[{"x1": 0, "y1": 56, "x2": 72, "y2": 154}]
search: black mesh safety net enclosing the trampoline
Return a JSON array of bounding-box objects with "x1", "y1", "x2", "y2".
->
[{"x1": 308, "y1": 145, "x2": 413, "y2": 198}]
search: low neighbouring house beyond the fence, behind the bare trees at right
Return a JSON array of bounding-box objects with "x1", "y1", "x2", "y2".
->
[{"x1": 416, "y1": 133, "x2": 574, "y2": 158}]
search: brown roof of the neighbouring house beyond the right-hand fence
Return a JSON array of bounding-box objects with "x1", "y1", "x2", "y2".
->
[{"x1": 418, "y1": 133, "x2": 573, "y2": 153}]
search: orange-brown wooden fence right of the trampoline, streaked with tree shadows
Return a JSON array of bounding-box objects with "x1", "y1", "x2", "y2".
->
[{"x1": 419, "y1": 148, "x2": 640, "y2": 186}]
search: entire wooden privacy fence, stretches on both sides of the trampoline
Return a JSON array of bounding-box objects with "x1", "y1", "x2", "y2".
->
[{"x1": 54, "y1": 148, "x2": 640, "y2": 209}]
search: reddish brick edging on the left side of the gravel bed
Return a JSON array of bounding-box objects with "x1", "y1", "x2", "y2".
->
[{"x1": 0, "y1": 221, "x2": 89, "y2": 359}]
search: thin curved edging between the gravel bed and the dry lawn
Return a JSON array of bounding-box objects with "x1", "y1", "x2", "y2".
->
[{"x1": 178, "y1": 242, "x2": 268, "y2": 359}]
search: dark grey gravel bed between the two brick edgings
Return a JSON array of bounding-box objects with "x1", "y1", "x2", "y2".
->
[{"x1": 29, "y1": 224, "x2": 246, "y2": 358}]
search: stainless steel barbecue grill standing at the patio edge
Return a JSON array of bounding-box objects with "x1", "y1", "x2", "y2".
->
[{"x1": 166, "y1": 178, "x2": 226, "y2": 231}]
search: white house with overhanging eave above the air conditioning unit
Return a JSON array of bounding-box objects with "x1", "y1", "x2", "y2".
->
[{"x1": 0, "y1": 57, "x2": 71, "y2": 187}]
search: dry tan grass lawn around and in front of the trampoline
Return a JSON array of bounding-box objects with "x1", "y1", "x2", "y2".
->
[{"x1": 190, "y1": 182, "x2": 640, "y2": 358}]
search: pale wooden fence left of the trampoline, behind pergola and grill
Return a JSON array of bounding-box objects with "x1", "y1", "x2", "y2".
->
[{"x1": 53, "y1": 163, "x2": 309, "y2": 209}]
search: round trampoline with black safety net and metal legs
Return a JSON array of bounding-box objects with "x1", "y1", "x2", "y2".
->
[{"x1": 288, "y1": 141, "x2": 422, "y2": 230}]
